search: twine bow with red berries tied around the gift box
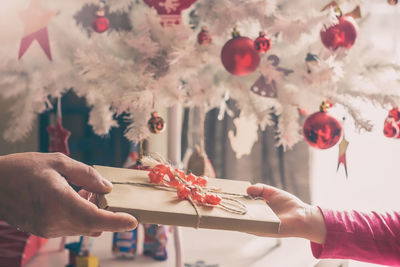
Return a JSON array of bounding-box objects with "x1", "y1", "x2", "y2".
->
[{"x1": 113, "y1": 158, "x2": 260, "y2": 228}]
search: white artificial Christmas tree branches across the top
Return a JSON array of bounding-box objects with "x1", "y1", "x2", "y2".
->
[{"x1": 0, "y1": 0, "x2": 400, "y2": 154}]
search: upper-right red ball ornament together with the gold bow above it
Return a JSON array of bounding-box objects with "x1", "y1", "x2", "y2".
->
[{"x1": 320, "y1": 2, "x2": 361, "y2": 51}]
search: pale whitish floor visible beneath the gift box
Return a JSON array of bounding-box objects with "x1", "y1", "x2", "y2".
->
[{"x1": 26, "y1": 228, "x2": 317, "y2": 267}]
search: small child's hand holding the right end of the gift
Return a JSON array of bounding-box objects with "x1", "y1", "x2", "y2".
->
[{"x1": 247, "y1": 184, "x2": 326, "y2": 244}]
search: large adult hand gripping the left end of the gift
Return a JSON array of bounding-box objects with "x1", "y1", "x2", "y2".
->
[{"x1": 0, "y1": 153, "x2": 137, "y2": 238}]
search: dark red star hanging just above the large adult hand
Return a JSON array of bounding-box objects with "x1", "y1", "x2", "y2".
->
[{"x1": 47, "y1": 117, "x2": 71, "y2": 156}]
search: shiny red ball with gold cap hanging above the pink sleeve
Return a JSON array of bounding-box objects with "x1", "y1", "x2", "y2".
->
[{"x1": 303, "y1": 101, "x2": 342, "y2": 149}]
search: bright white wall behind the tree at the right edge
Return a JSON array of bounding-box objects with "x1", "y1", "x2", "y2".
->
[{"x1": 311, "y1": 1, "x2": 400, "y2": 267}]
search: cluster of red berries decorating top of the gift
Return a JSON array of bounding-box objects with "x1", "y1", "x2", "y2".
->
[{"x1": 149, "y1": 164, "x2": 222, "y2": 206}]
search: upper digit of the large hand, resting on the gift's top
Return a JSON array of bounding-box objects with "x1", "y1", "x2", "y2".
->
[{"x1": 50, "y1": 153, "x2": 112, "y2": 193}]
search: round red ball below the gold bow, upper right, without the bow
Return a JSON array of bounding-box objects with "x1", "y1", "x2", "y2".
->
[{"x1": 321, "y1": 16, "x2": 357, "y2": 51}]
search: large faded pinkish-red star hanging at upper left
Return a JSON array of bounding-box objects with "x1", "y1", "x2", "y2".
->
[{"x1": 18, "y1": 0, "x2": 56, "y2": 61}]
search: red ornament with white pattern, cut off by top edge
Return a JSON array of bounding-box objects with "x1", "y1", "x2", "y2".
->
[{"x1": 143, "y1": 0, "x2": 196, "y2": 26}]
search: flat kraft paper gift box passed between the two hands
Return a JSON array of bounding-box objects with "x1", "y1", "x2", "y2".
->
[{"x1": 95, "y1": 166, "x2": 280, "y2": 234}]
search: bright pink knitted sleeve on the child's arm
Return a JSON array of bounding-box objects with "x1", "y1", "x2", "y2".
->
[{"x1": 311, "y1": 209, "x2": 400, "y2": 266}]
